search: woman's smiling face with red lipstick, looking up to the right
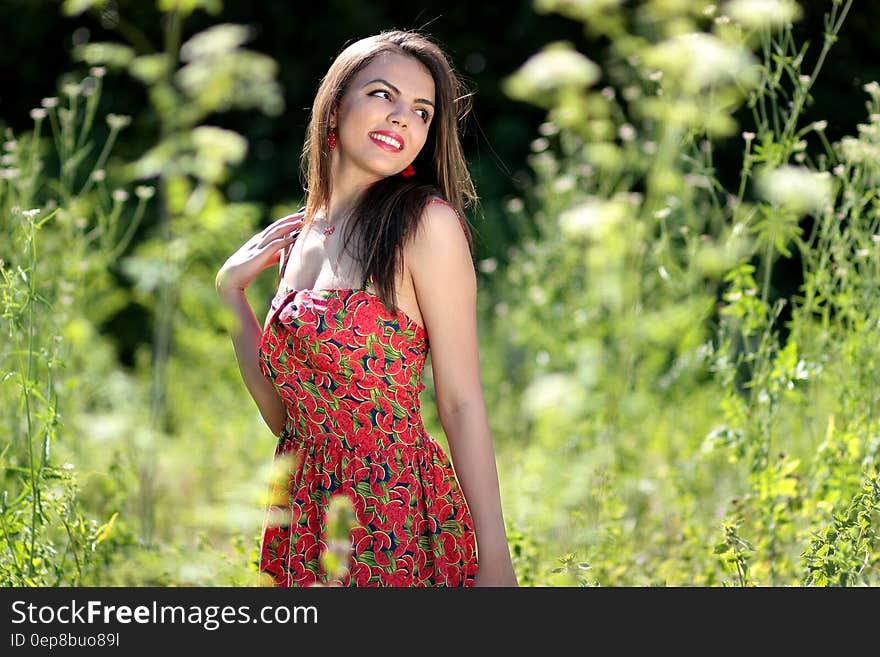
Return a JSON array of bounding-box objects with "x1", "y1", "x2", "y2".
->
[{"x1": 330, "y1": 52, "x2": 435, "y2": 179}]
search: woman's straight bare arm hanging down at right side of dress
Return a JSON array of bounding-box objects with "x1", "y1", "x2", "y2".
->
[{"x1": 405, "y1": 203, "x2": 517, "y2": 586}]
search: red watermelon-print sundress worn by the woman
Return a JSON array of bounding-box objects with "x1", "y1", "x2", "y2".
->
[{"x1": 259, "y1": 199, "x2": 477, "y2": 586}]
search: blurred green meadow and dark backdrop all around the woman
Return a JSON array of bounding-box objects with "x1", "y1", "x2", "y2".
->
[{"x1": 0, "y1": 0, "x2": 880, "y2": 586}]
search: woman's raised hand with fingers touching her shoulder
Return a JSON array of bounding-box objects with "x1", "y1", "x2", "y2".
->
[{"x1": 214, "y1": 213, "x2": 303, "y2": 296}]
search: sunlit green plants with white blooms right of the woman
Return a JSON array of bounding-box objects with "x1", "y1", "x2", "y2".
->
[{"x1": 485, "y1": 0, "x2": 880, "y2": 585}]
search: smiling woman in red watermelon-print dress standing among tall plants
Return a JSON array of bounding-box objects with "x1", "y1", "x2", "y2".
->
[{"x1": 217, "y1": 30, "x2": 517, "y2": 586}]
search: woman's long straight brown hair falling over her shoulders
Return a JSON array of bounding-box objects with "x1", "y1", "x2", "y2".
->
[{"x1": 300, "y1": 30, "x2": 479, "y2": 312}]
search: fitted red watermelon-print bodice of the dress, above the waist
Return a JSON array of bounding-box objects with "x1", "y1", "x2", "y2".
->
[{"x1": 260, "y1": 288, "x2": 428, "y2": 448}]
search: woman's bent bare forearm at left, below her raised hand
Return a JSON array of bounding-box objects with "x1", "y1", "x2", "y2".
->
[{"x1": 217, "y1": 287, "x2": 287, "y2": 436}]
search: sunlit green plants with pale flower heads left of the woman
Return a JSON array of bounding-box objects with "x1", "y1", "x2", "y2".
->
[{"x1": 0, "y1": 2, "x2": 281, "y2": 585}]
